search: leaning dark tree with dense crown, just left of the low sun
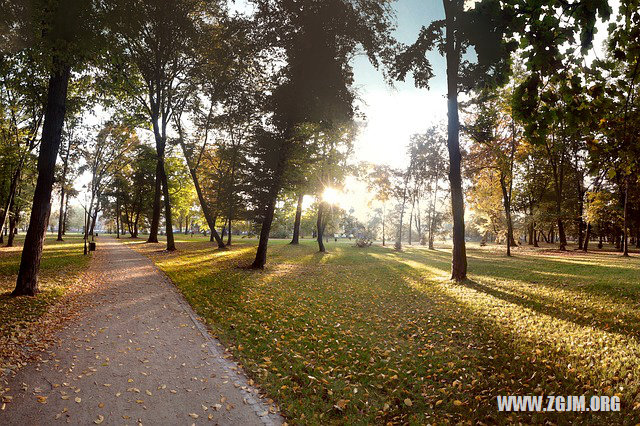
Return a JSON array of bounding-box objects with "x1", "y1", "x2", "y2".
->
[{"x1": 246, "y1": 0, "x2": 390, "y2": 268}]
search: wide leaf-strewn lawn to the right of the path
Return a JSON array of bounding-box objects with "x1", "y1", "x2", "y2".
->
[{"x1": 134, "y1": 236, "x2": 640, "y2": 424}]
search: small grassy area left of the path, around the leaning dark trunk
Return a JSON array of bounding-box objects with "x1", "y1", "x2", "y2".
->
[{"x1": 0, "y1": 235, "x2": 89, "y2": 358}]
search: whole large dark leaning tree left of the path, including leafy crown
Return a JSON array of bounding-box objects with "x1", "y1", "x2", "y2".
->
[{"x1": 9, "y1": 0, "x2": 101, "y2": 296}]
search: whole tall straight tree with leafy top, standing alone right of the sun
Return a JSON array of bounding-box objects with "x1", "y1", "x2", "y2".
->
[{"x1": 392, "y1": 0, "x2": 516, "y2": 281}]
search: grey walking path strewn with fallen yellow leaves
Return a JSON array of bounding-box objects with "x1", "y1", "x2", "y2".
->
[{"x1": 0, "y1": 237, "x2": 282, "y2": 425}]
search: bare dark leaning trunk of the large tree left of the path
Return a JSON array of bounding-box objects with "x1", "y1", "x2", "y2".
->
[{"x1": 11, "y1": 58, "x2": 70, "y2": 296}]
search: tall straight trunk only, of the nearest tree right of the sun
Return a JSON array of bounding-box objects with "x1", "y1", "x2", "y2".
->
[{"x1": 445, "y1": 10, "x2": 467, "y2": 282}]
